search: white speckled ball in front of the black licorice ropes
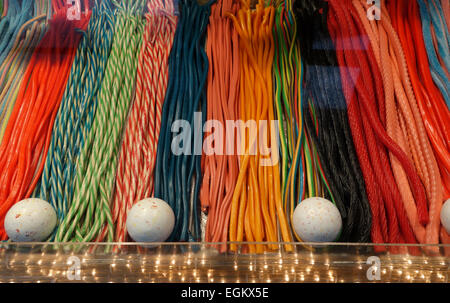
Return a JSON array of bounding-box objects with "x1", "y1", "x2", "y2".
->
[{"x1": 293, "y1": 197, "x2": 342, "y2": 242}]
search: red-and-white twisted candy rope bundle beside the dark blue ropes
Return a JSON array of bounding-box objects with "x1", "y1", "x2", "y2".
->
[{"x1": 113, "y1": 0, "x2": 177, "y2": 242}]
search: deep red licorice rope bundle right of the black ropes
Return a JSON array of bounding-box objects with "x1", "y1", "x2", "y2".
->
[{"x1": 329, "y1": 0, "x2": 428, "y2": 247}]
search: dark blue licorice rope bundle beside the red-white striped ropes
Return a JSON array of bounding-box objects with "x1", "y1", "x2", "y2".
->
[{"x1": 155, "y1": 0, "x2": 213, "y2": 241}]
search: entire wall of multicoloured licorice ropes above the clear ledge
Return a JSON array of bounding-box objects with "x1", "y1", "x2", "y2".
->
[{"x1": 0, "y1": 0, "x2": 450, "y2": 253}]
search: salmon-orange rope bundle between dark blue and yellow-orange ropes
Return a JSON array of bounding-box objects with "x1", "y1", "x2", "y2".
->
[{"x1": 200, "y1": 0, "x2": 240, "y2": 252}]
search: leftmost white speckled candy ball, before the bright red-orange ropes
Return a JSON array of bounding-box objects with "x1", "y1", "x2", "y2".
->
[{"x1": 5, "y1": 198, "x2": 56, "y2": 242}]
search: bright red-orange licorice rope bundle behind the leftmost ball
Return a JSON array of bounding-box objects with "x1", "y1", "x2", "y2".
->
[{"x1": 0, "y1": 0, "x2": 90, "y2": 240}]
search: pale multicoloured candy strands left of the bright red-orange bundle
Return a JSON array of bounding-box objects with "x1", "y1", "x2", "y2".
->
[{"x1": 0, "y1": 1, "x2": 48, "y2": 142}]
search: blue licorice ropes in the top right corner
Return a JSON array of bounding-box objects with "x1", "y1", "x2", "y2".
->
[{"x1": 417, "y1": 0, "x2": 450, "y2": 108}]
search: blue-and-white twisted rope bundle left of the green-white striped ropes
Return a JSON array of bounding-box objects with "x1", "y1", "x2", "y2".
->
[{"x1": 34, "y1": 0, "x2": 115, "y2": 229}]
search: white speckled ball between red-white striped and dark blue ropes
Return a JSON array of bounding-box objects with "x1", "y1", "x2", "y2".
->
[{"x1": 127, "y1": 198, "x2": 175, "y2": 242}]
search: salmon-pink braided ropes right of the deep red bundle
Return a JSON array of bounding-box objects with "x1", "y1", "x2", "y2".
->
[{"x1": 353, "y1": 0, "x2": 442, "y2": 249}]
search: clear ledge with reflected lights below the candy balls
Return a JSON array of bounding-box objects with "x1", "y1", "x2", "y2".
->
[{"x1": 0, "y1": 243, "x2": 450, "y2": 283}]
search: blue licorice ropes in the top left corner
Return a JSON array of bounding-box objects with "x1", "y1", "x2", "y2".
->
[{"x1": 0, "y1": 0, "x2": 33, "y2": 64}]
